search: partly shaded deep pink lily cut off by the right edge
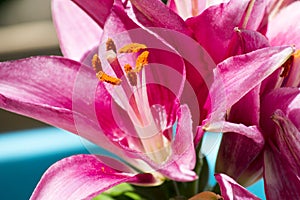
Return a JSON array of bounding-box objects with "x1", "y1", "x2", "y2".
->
[{"x1": 210, "y1": 2, "x2": 300, "y2": 199}]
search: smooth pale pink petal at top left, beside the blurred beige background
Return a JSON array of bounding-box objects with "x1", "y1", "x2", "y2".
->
[{"x1": 52, "y1": 0, "x2": 102, "y2": 61}]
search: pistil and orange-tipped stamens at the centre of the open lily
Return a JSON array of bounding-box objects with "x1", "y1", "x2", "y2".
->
[{"x1": 92, "y1": 39, "x2": 171, "y2": 163}]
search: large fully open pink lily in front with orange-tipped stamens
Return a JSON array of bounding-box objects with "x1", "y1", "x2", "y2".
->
[{"x1": 0, "y1": 0, "x2": 293, "y2": 199}]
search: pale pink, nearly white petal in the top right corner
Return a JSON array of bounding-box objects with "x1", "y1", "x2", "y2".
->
[{"x1": 267, "y1": 1, "x2": 300, "y2": 49}]
